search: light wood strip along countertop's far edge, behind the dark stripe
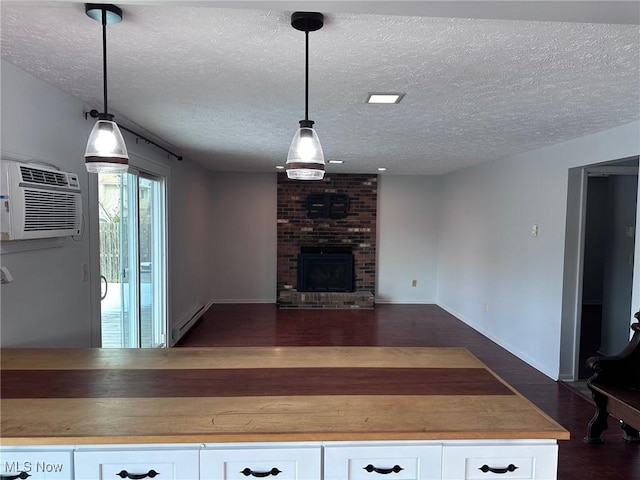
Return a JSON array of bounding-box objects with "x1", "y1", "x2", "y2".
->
[{"x1": 0, "y1": 346, "x2": 484, "y2": 370}]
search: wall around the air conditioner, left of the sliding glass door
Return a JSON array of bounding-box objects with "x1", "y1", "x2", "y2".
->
[{"x1": 0, "y1": 61, "x2": 93, "y2": 347}]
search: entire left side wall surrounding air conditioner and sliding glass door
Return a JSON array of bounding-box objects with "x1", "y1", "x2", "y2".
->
[{"x1": 0, "y1": 61, "x2": 213, "y2": 347}]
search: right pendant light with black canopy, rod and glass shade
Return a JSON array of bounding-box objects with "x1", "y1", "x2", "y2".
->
[{"x1": 287, "y1": 12, "x2": 324, "y2": 180}]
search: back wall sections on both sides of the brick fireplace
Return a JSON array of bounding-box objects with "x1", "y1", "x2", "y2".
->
[{"x1": 203, "y1": 172, "x2": 439, "y2": 303}]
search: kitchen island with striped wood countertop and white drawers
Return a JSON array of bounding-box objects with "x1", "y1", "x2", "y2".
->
[{"x1": 0, "y1": 347, "x2": 569, "y2": 480}]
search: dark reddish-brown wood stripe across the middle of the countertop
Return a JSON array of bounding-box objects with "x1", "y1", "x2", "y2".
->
[{"x1": 0, "y1": 367, "x2": 513, "y2": 399}]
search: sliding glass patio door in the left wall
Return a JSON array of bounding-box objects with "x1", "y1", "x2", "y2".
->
[{"x1": 98, "y1": 171, "x2": 167, "y2": 348}]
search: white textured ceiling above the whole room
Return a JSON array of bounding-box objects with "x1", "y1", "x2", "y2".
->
[{"x1": 0, "y1": 0, "x2": 640, "y2": 175}]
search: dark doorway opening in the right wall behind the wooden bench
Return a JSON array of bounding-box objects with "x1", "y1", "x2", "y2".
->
[{"x1": 561, "y1": 157, "x2": 638, "y2": 380}]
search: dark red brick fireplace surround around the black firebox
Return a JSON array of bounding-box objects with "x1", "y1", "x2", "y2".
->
[{"x1": 277, "y1": 173, "x2": 378, "y2": 308}]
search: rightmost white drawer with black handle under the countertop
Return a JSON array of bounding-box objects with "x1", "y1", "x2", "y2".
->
[{"x1": 442, "y1": 443, "x2": 558, "y2": 480}]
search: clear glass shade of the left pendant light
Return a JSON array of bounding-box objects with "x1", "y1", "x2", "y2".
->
[{"x1": 84, "y1": 120, "x2": 129, "y2": 173}]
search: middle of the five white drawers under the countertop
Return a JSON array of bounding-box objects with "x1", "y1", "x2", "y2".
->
[{"x1": 200, "y1": 446, "x2": 322, "y2": 480}]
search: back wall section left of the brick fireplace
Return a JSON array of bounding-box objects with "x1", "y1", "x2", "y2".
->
[{"x1": 206, "y1": 172, "x2": 277, "y2": 303}]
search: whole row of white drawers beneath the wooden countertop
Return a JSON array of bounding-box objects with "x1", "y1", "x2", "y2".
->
[{"x1": 0, "y1": 440, "x2": 558, "y2": 480}]
